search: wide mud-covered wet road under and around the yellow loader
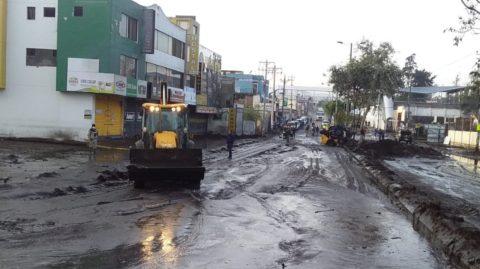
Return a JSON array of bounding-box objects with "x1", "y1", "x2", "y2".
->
[{"x1": 0, "y1": 132, "x2": 450, "y2": 268}]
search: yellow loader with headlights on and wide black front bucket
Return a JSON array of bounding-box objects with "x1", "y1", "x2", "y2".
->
[{"x1": 127, "y1": 83, "x2": 205, "y2": 188}]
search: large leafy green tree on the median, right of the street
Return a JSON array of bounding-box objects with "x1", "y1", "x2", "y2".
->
[{"x1": 329, "y1": 40, "x2": 403, "y2": 130}]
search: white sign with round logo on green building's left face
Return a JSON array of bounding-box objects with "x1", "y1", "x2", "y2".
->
[{"x1": 67, "y1": 72, "x2": 115, "y2": 94}]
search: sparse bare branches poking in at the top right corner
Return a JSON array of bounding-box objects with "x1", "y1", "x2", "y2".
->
[{"x1": 444, "y1": 0, "x2": 480, "y2": 46}]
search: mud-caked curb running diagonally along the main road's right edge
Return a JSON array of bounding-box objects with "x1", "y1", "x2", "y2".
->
[{"x1": 343, "y1": 147, "x2": 480, "y2": 269}]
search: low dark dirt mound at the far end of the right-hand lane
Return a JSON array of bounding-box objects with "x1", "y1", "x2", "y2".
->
[{"x1": 352, "y1": 140, "x2": 442, "y2": 158}]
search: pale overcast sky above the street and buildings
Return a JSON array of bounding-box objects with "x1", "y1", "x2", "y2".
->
[{"x1": 135, "y1": 0, "x2": 480, "y2": 86}]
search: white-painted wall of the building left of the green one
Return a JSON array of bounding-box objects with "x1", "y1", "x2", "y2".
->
[{"x1": 0, "y1": 0, "x2": 95, "y2": 140}]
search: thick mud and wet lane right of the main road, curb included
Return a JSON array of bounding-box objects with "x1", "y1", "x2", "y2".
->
[{"x1": 346, "y1": 139, "x2": 480, "y2": 268}]
